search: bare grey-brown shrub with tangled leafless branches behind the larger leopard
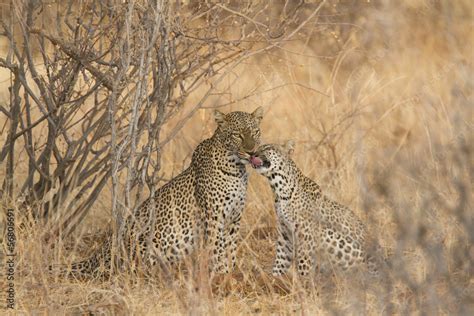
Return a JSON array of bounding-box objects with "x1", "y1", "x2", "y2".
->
[{"x1": 0, "y1": 1, "x2": 317, "y2": 249}]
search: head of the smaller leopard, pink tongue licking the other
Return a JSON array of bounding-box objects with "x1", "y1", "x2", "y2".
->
[{"x1": 249, "y1": 140, "x2": 295, "y2": 175}]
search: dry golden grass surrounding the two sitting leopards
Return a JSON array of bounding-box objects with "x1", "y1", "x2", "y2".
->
[{"x1": 0, "y1": 1, "x2": 474, "y2": 315}]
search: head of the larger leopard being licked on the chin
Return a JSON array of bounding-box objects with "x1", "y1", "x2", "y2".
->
[{"x1": 214, "y1": 107, "x2": 263, "y2": 158}]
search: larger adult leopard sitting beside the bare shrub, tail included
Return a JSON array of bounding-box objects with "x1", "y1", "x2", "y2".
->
[{"x1": 58, "y1": 107, "x2": 263, "y2": 277}]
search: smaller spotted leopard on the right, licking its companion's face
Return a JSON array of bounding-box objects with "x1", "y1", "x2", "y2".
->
[{"x1": 249, "y1": 141, "x2": 376, "y2": 276}]
